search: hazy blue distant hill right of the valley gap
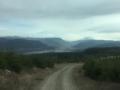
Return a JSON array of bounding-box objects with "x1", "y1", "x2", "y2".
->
[{"x1": 73, "y1": 40, "x2": 120, "y2": 50}]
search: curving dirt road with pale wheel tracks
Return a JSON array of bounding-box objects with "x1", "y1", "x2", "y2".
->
[{"x1": 38, "y1": 64, "x2": 78, "y2": 90}]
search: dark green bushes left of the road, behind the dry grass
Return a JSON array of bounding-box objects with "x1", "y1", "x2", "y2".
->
[{"x1": 0, "y1": 53, "x2": 53, "y2": 73}]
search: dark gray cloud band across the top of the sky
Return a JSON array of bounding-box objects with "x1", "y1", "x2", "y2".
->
[{"x1": 0, "y1": 0, "x2": 120, "y2": 18}]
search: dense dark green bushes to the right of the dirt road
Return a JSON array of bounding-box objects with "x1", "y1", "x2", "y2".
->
[{"x1": 83, "y1": 58, "x2": 120, "y2": 82}]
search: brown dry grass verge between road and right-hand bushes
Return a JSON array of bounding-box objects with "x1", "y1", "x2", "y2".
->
[{"x1": 75, "y1": 65, "x2": 120, "y2": 90}]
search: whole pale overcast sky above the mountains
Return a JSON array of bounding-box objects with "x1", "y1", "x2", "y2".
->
[{"x1": 0, "y1": 0, "x2": 120, "y2": 40}]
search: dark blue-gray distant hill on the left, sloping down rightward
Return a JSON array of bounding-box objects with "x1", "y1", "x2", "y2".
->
[{"x1": 0, "y1": 37, "x2": 54, "y2": 52}]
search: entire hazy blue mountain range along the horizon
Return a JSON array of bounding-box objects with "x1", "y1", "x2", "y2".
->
[{"x1": 0, "y1": 37, "x2": 120, "y2": 52}]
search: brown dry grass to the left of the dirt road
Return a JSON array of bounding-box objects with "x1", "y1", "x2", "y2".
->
[{"x1": 0, "y1": 69, "x2": 51, "y2": 90}]
